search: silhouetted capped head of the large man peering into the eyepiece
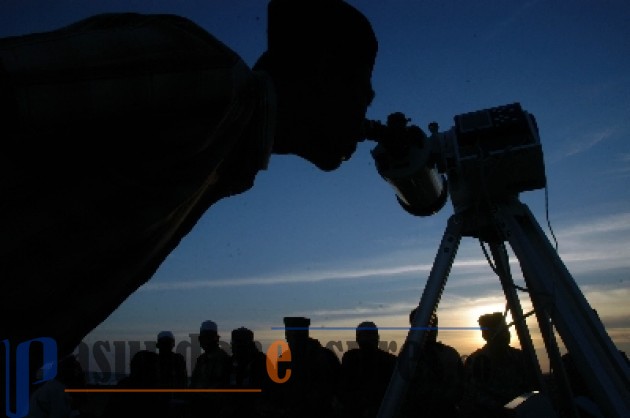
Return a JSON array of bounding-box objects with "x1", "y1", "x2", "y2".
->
[{"x1": 254, "y1": 0, "x2": 378, "y2": 171}]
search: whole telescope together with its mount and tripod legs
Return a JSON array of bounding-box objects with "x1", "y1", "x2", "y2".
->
[{"x1": 365, "y1": 103, "x2": 630, "y2": 418}]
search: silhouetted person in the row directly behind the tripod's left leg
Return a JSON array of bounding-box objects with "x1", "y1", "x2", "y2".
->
[{"x1": 400, "y1": 307, "x2": 464, "y2": 418}]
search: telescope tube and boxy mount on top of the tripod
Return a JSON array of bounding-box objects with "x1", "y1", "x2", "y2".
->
[{"x1": 365, "y1": 103, "x2": 546, "y2": 216}]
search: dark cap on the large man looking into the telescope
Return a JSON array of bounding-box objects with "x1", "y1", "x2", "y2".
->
[{"x1": 267, "y1": 0, "x2": 378, "y2": 68}]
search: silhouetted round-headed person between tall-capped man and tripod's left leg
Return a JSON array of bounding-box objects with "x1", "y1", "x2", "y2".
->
[{"x1": 338, "y1": 321, "x2": 396, "y2": 418}]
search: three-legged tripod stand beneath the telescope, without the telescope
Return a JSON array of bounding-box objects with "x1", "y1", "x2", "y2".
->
[{"x1": 378, "y1": 197, "x2": 630, "y2": 418}]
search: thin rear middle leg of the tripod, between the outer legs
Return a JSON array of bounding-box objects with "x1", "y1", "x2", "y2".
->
[{"x1": 490, "y1": 242, "x2": 548, "y2": 394}]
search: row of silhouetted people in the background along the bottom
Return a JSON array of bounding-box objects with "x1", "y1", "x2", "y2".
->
[{"x1": 31, "y1": 308, "x2": 584, "y2": 418}]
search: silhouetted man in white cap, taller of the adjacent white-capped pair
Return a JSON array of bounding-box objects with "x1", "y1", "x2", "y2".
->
[{"x1": 190, "y1": 320, "x2": 231, "y2": 417}]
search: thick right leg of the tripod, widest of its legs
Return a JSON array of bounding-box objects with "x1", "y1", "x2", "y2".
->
[{"x1": 496, "y1": 202, "x2": 630, "y2": 417}]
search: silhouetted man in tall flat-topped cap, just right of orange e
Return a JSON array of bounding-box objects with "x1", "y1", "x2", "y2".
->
[{"x1": 278, "y1": 317, "x2": 341, "y2": 418}]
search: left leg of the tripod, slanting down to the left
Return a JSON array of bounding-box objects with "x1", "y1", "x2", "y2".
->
[{"x1": 378, "y1": 214, "x2": 463, "y2": 418}]
